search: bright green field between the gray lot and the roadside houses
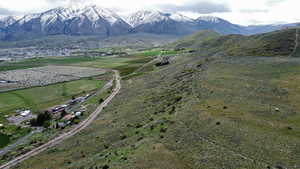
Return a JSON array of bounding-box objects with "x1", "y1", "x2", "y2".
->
[{"x1": 0, "y1": 78, "x2": 105, "y2": 122}]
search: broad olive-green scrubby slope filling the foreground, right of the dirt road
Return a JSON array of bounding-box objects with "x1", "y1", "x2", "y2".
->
[{"x1": 17, "y1": 52, "x2": 300, "y2": 169}]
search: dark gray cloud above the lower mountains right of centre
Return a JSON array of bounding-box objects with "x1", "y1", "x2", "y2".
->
[{"x1": 159, "y1": 1, "x2": 231, "y2": 14}]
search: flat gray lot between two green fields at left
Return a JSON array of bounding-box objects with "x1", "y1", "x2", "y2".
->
[{"x1": 0, "y1": 66, "x2": 105, "y2": 91}]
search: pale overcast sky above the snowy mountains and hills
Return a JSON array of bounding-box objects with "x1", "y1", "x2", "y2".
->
[{"x1": 0, "y1": 0, "x2": 300, "y2": 25}]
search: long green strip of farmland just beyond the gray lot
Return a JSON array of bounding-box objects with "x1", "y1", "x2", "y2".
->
[{"x1": 0, "y1": 49, "x2": 179, "y2": 76}]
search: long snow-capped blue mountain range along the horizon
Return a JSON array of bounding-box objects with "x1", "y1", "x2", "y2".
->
[{"x1": 0, "y1": 5, "x2": 298, "y2": 40}]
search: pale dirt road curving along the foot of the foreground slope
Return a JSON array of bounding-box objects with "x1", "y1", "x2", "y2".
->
[{"x1": 0, "y1": 70, "x2": 121, "y2": 169}]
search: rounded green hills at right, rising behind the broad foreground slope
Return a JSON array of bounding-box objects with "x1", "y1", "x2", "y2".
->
[{"x1": 177, "y1": 29, "x2": 296, "y2": 56}]
